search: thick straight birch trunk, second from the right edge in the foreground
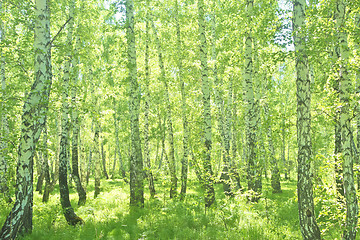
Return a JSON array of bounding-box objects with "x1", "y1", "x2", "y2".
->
[{"x1": 293, "y1": 0, "x2": 321, "y2": 240}]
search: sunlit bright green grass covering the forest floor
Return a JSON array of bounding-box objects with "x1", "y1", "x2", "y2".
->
[{"x1": 0, "y1": 173, "x2": 340, "y2": 240}]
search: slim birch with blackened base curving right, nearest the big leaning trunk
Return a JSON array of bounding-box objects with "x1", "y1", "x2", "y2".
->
[{"x1": 59, "y1": 0, "x2": 83, "y2": 225}]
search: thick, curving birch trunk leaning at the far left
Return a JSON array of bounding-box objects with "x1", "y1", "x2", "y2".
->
[{"x1": 0, "y1": 0, "x2": 52, "y2": 237}]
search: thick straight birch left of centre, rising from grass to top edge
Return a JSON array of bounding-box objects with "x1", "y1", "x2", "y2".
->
[{"x1": 125, "y1": 0, "x2": 144, "y2": 207}]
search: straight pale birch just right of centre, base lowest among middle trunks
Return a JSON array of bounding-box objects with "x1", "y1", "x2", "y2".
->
[{"x1": 198, "y1": 0, "x2": 215, "y2": 207}]
